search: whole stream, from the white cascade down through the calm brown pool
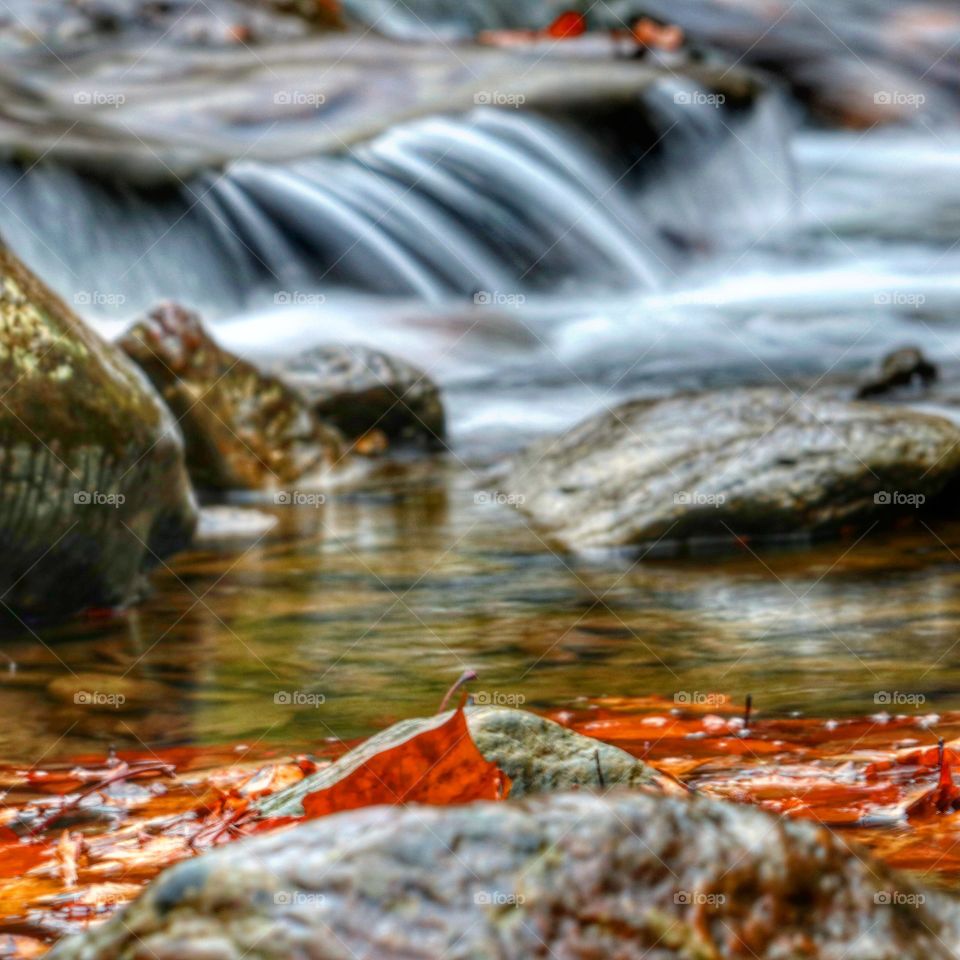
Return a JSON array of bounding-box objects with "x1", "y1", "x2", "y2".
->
[{"x1": 0, "y1": 0, "x2": 960, "y2": 761}]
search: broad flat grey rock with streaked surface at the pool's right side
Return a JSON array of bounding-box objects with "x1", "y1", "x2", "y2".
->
[{"x1": 499, "y1": 388, "x2": 960, "y2": 549}]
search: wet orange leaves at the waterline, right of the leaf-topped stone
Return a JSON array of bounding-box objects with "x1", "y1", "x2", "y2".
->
[{"x1": 549, "y1": 695, "x2": 960, "y2": 883}]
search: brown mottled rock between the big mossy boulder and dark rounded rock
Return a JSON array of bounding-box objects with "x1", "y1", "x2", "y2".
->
[{"x1": 119, "y1": 303, "x2": 343, "y2": 490}]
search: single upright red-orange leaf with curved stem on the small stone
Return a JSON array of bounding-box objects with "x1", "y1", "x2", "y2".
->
[{"x1": 303, "y1": 709, "x2": 510, "y2": 817}]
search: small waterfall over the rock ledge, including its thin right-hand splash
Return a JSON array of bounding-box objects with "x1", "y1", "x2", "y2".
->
[{"x1": 0, "y1": 82, "x2": 789, "y2": 318}]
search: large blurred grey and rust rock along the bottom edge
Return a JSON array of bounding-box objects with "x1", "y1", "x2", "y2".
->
[{"x1": 49, "y1": 791, "x2": 960, "y2": 960}]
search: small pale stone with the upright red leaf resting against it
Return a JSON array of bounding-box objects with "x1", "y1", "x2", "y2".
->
[{"x1": 261, "y1": 706, "x2": 683, "y2": 816}]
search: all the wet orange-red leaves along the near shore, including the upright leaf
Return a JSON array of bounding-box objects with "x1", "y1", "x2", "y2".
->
[{"x1": 0, "y1": 697, "x2": 960, "y2": 958}]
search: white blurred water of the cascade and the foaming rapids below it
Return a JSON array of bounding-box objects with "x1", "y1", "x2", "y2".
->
[{"x1": 0, "y1": 51, "x2": 960, "y2": 451}]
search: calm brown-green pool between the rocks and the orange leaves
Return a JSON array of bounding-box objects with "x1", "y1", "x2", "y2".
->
[{"x1": 0, "y1": 465, "x2": 960, "y2": 762}]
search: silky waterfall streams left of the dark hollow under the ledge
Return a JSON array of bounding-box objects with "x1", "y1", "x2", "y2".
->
[{"x1": 0, "y1": 109, "x2": 664, "y2": 315}]
